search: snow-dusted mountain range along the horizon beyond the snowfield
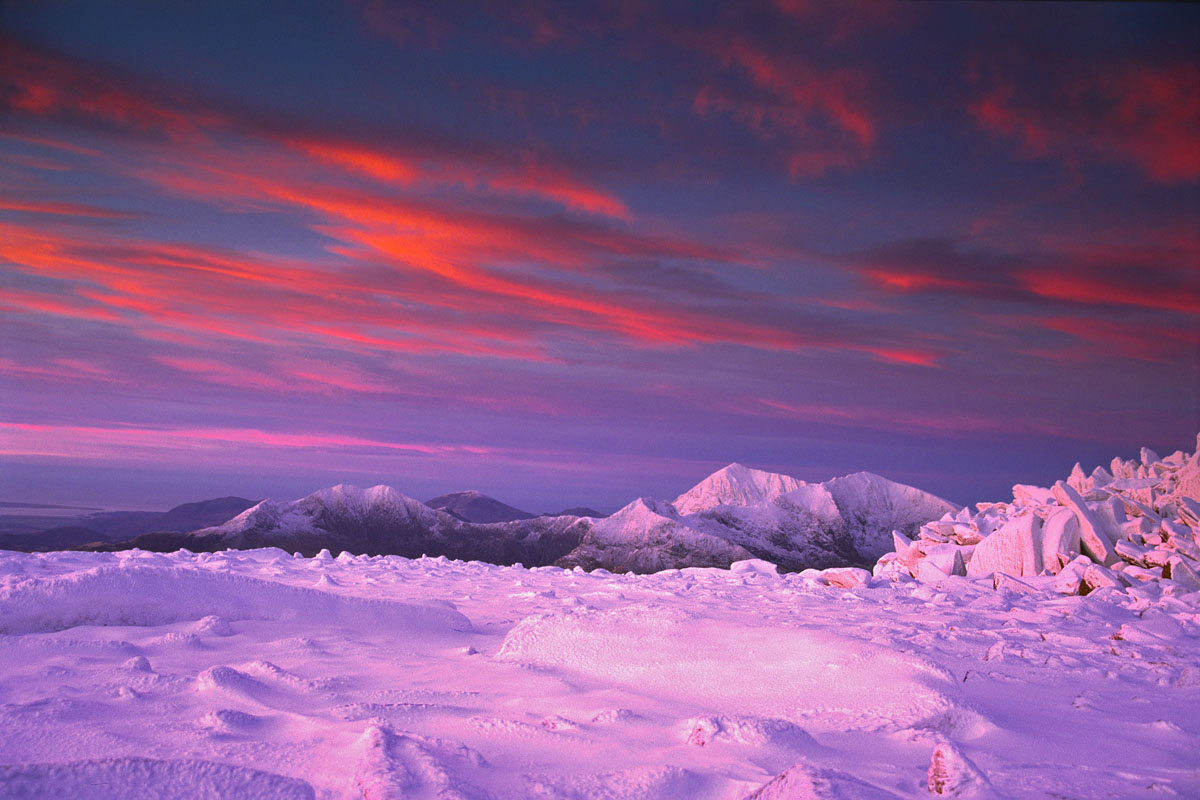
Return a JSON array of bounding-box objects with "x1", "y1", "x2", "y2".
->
[{"x1": 54, "y1": 464, "x2": 958, "y2": 572}]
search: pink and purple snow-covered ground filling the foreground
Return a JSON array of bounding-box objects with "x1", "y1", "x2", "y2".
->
[{"x1": 0, "y1": 549, "x2": 1200, "y2": 800}]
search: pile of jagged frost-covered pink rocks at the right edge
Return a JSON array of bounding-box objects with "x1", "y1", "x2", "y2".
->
[{"x1": 874, "y1": 435, "x2": 1200, "y2": 594}]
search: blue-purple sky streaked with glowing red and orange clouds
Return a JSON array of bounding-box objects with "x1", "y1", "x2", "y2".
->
[{"x1": 0, "y1": 0, "x2": 1200, "y2": 512}]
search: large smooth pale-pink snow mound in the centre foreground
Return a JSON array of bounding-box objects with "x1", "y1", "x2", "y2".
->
[{"x1": 497, "y1": 606, "x2": 958, "y2": 730}]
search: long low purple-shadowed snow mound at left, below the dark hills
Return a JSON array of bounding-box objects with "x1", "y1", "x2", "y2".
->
[{"x1": 0, "y1": 564, "x2": 470, "y2": 634}]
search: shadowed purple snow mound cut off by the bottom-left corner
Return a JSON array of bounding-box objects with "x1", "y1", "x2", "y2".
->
[{"x1": 0, "y1": 758, "x2": 317, "y2": 800}]
